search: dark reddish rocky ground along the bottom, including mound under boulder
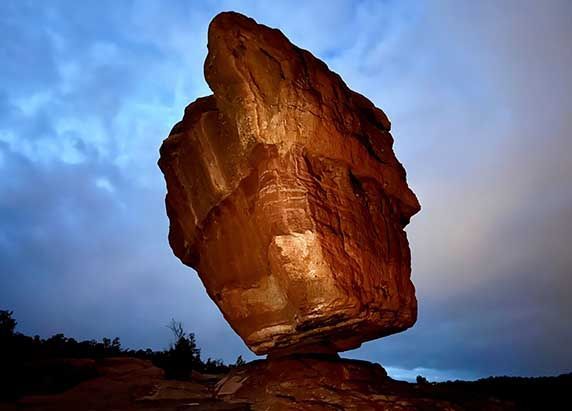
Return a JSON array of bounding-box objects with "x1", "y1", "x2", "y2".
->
[{"x1": 0, "y1": 356, "x2": 560, "y2": 411}]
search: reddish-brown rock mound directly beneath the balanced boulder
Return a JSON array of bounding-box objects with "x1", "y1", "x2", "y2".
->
[{"x1": 215, "y1": 356, "x2": 464, "y2": 411}]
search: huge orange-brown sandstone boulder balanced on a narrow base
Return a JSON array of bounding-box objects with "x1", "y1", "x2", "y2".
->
[{"x1": 159, "y1": 13, "x2": 420, "y2": 355}]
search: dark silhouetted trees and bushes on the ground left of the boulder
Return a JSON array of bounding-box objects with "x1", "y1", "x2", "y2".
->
[{"x1": 0, "y1": 310, "x2": 244, "y2": 399}]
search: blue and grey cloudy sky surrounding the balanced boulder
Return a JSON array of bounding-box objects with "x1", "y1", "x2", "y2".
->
[{"x1": 0, "y1": 0, "x2": 572, "y2": 379}]
